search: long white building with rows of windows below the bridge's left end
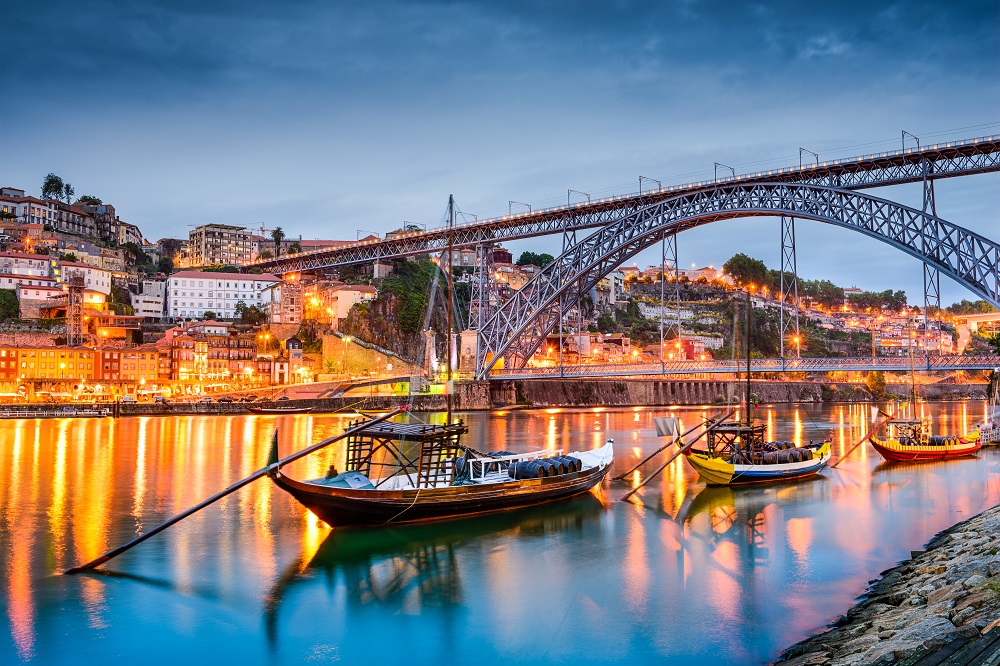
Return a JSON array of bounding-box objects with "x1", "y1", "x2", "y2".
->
[{"x1": 166, "y1": 271, "x2": 281, "y2": 320}]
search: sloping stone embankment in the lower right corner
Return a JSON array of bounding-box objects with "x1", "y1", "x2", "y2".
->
[{"x1": 775, "y1": 506, "x2": 1000, "y2": 666}]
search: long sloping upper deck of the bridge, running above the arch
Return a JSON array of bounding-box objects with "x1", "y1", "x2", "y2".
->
[{"x1": 250, "y1": 137, "x2": 1000, "y2": 274}]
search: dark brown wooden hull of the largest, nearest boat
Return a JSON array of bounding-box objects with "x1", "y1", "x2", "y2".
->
[{"x1": 271, "y1": 462, "x2": 612, "y2": 527}]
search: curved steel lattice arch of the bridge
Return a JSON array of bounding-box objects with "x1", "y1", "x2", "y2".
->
[{"x1": 476, "y1": 183, "x2": 1000, "y2": 376}]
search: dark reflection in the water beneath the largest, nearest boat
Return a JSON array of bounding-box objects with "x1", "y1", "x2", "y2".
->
[{"x1": 264, "y1": 493, "x2": 604, "y2": 645}]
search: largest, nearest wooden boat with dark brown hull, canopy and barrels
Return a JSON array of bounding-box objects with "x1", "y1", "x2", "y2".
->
[{"x1": 269, "y1": 421, "x2": 614, "y2": 527}]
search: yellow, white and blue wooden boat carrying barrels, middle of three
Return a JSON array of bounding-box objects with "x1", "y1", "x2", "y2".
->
[{"x1": 684, "y1": 423, "x2": 831, "y2": 486}]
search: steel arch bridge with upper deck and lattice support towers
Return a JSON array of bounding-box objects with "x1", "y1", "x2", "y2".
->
[{"x1": 247, "y1": 132, "x2": 1000, "y2": 378}]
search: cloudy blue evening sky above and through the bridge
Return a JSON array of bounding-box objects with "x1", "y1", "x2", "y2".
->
[{"x1": 0, "y1": 0, "x2": 1000, "y2": 304}]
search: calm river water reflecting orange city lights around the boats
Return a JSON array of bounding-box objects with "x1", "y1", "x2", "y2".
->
[{"x1": 0, "y1": 402, "x2": 1000, "y2": 665}]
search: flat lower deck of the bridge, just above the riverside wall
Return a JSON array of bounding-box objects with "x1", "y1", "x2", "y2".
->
[{"x1": 487, "y1": 355, "x2": 1000, "y2": 380}]
